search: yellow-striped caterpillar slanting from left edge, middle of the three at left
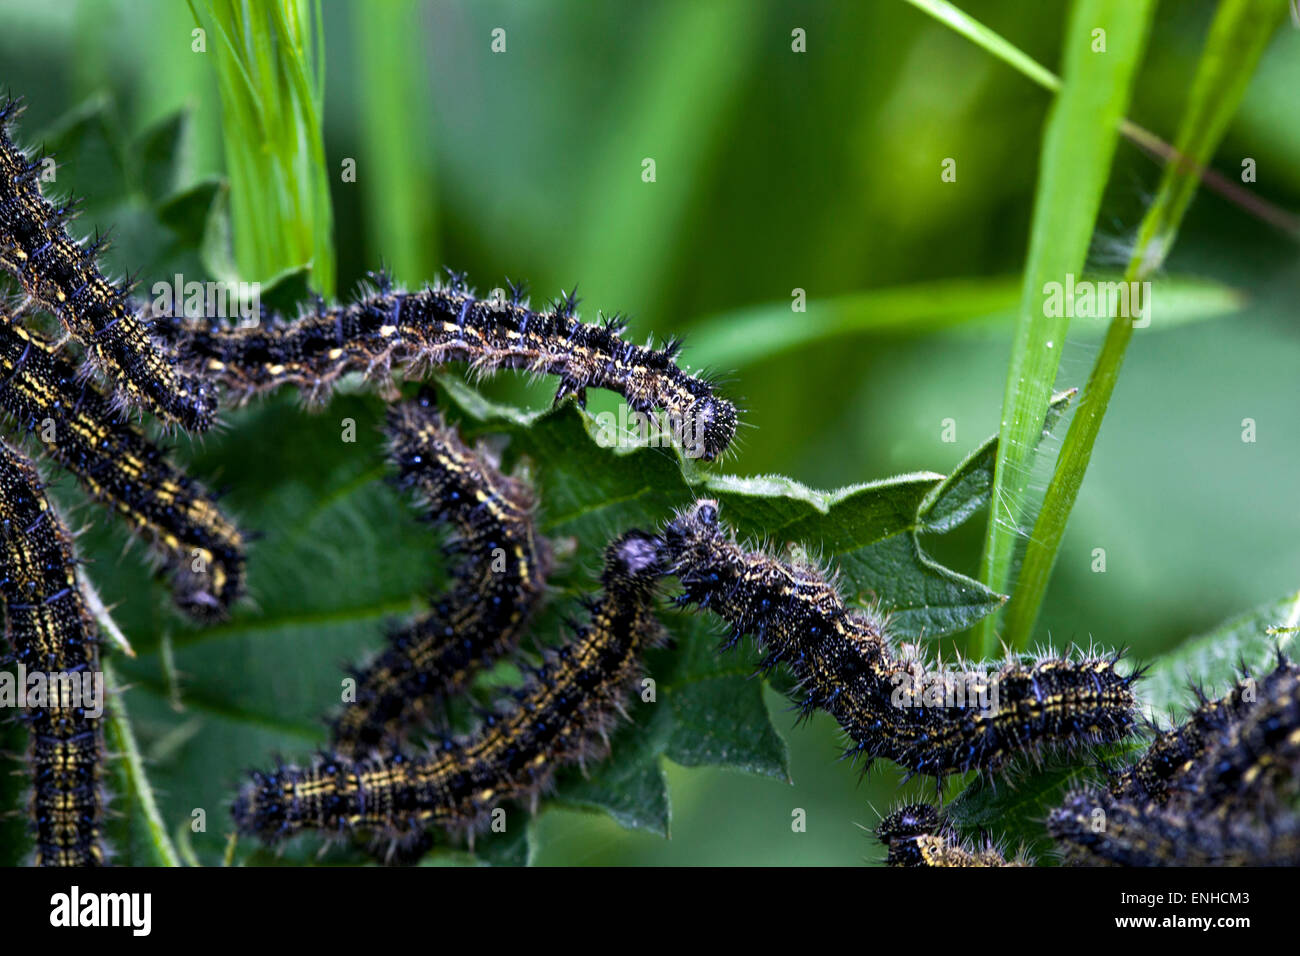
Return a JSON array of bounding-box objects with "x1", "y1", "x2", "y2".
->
[{"x1": 0, "y1": 316, "x2": 246, "y2": 619}]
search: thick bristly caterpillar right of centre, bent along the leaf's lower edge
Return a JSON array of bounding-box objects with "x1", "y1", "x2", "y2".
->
[{"x1": 662, "y1": 499, "x2": 1139, "y2": 778}]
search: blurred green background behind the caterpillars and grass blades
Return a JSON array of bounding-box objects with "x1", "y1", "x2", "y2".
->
[{"x1": 0, "y1": 0, "x2": 1300, "y2": 865}]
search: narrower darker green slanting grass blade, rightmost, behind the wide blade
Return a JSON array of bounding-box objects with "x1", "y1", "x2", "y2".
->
[{"x1": 1004, "y1": 0, "x2": 1286, "y2": 648}]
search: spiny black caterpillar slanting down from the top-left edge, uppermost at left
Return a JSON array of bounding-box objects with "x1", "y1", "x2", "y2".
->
[{"x1": 0, "y1": 99, "x2": 216, "y2": 431}]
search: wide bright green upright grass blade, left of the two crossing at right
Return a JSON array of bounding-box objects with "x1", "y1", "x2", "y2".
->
[{"x1": 976, "y1": 0, "x2": 1154, "y2": 656}]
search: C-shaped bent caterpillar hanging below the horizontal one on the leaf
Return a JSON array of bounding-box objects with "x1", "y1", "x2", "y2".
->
[{"x1": 333, "y1": 389, "x2": 550, "y2": 757}]
